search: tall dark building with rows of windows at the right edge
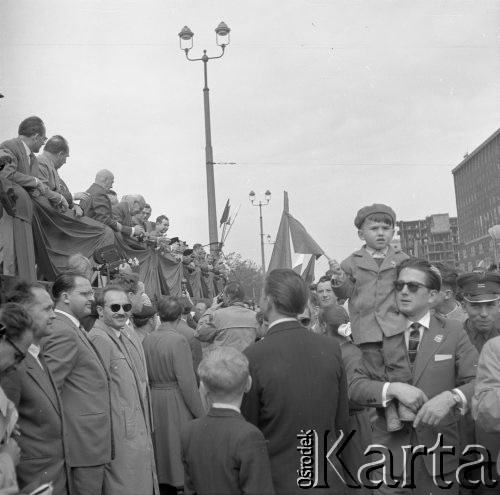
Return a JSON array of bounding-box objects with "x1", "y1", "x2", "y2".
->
[{"x1": 452, "y1": 129, "x2": 500, "y2": 271}]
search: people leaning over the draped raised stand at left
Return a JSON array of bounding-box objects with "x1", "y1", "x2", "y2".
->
[{"x1": 0, "y1": 117, "x2": 227, "y2": 298}]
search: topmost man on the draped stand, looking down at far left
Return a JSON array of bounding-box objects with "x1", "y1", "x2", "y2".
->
[{"x1": 0, "y1": 117, "x2": 47, "y2": 280}]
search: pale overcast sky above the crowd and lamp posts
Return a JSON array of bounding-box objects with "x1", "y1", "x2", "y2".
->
[{"x1": 0, "y1": 0, "x2": 500, "y2": 274}]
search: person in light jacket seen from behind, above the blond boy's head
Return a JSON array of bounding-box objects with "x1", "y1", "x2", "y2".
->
[{"x1": 196, "y1": 282, "x2": 261, "y2": 352}]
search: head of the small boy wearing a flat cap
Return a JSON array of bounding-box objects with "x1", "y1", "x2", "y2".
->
[{"x1": 354, "y1": 204, "x2": 396, "y2": 250}]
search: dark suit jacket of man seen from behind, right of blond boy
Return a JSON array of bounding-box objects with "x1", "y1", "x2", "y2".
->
[{"x1": 241, "y1": 321, "x2": 349, "y2": 495}]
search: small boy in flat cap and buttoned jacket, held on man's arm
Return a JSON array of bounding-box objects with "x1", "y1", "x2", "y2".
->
[{"x1": 330, "y1": 204, "x2": 415, "y2": 431}]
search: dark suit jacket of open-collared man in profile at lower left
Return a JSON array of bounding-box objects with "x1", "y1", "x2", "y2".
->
[{"x1": 2, "y1": 354, "x2": 68, "y2": 495}]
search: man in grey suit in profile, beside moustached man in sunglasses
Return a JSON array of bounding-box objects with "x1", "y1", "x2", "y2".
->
[{"x1": 43, "y1": 273, "x2": 113, "y2": 495}]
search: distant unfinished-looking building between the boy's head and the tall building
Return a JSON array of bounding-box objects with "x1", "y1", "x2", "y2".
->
[{"x1": 397, "y1": 213, "x2": 460, "y2": 268}]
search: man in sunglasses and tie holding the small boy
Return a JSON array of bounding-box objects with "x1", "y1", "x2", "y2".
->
[{"x1": 350, "y1": 259, "x2": 478, "y2": 495}]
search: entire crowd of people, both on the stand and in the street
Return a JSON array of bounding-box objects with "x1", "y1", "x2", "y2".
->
[{"x1": 0, "y1": 117, "x2": 500, "y2": 495}]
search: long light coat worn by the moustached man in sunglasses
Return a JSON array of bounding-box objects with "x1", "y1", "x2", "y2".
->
[{"x1": 89, "y1": 320, "x2": 159, "y2": 495}]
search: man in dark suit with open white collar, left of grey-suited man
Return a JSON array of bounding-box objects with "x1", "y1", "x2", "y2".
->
[{"x1": 2, "y1": 281, "x2": 68, "y2": 495}]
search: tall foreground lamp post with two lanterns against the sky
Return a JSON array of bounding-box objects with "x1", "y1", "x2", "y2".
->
[{"x1": 179, "y1": 22, "x2": 231, "y2": 255}]
